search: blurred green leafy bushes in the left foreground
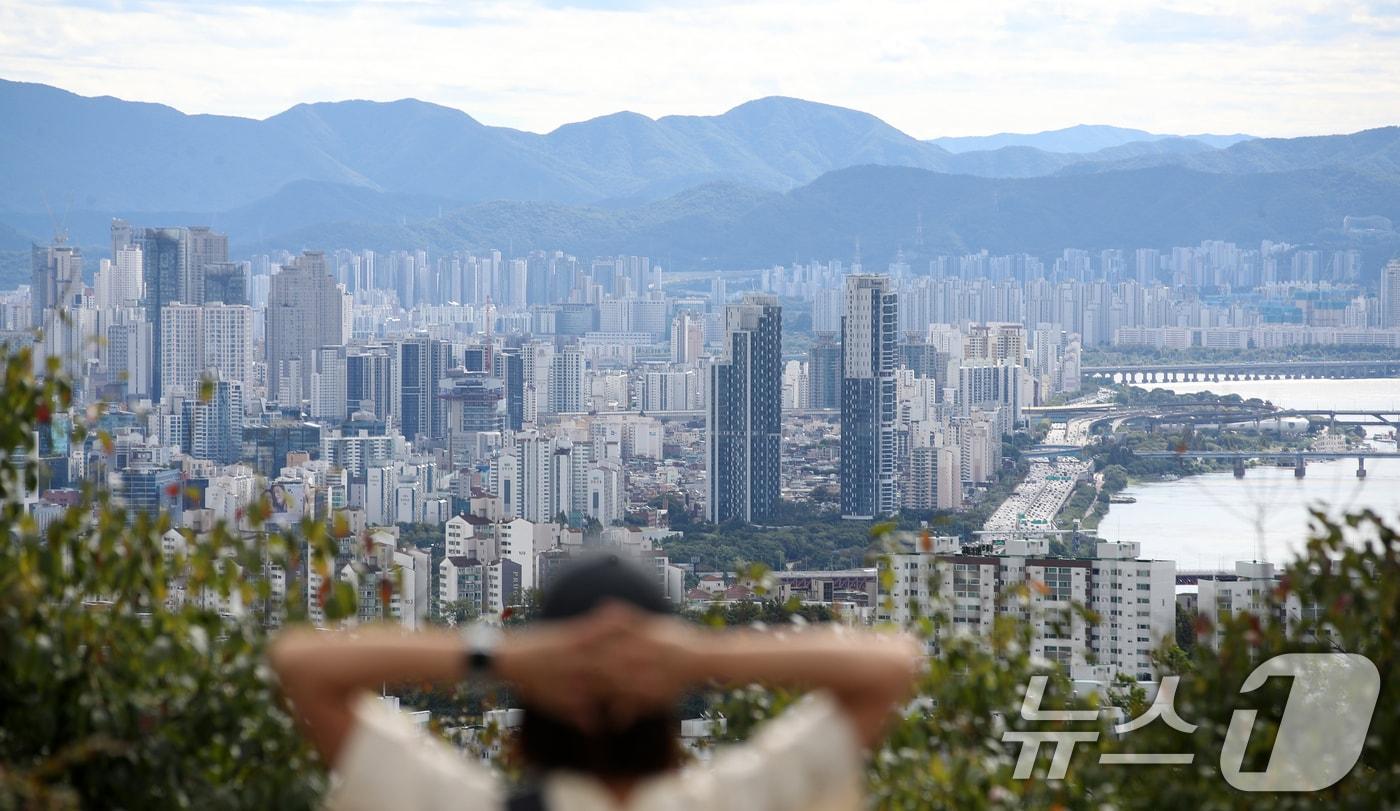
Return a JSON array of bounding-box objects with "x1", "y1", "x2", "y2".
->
[{"x1": 0, "y1": 349, "x2": 333, "y2": 808}]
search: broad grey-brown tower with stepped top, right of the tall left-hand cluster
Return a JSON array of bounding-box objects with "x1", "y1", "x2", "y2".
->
[{"x1": 266, "y1": 251, "x2": 346, "y2": 402}]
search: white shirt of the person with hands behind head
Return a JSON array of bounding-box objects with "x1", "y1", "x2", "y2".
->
[{"x1": 330, "y1": 693, "x2": 864, "y2": 811}]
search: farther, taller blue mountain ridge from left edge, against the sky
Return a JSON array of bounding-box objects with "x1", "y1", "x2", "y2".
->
[{"x1": 0, "y1": 80, "x2": 1299, "y2": 214}]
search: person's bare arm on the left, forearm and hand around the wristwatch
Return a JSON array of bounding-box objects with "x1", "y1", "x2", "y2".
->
[{"x1": 269, "y1": 618, "x2": 609, "y2": 765}]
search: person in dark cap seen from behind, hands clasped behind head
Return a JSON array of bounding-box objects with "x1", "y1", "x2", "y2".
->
[{"x1": 270, "y1": 556, "x2": 921, "y2": 811}]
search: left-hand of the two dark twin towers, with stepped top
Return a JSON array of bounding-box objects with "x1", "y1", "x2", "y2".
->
[{"x1": 706, "y1": 293, "x2": 783, "y2": 524}]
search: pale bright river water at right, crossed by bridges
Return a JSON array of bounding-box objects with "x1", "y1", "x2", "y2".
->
[{"x1": 1099, "y1": 378, "x2": 1400, "y2": 570}]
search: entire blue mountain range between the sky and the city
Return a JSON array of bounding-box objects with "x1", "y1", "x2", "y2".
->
[{"x1": 0, "y1": 81, "x2": 1400, "y2": 275}]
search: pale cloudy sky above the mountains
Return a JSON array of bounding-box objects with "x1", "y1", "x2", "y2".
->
[{"x1": 0, "y1": 0, "x2": 1400, "y2": 137}]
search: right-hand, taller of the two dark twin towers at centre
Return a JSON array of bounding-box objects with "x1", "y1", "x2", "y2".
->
[{"x1": 841, "y1": 275, "x2": 899, "y2": 518}]
